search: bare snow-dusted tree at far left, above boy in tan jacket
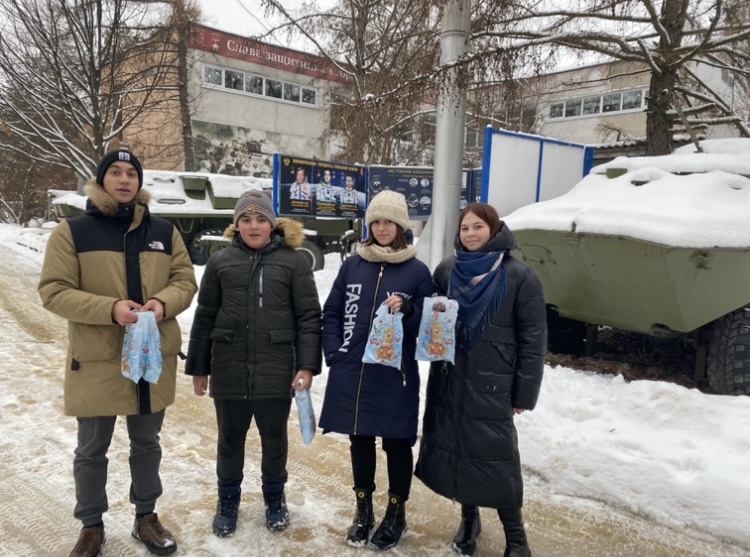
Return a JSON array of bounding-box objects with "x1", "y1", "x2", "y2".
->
[{"x1": 0, "y1": 0, "x2": 197, "y2": 178}]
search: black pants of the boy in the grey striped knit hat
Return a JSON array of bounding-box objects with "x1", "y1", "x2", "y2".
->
[{"x1": 214, "y1": 399, "x2": 292, "y2": 493}]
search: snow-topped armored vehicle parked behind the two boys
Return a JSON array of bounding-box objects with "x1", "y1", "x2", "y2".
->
[{"x1": 50, "y1": 170, "x2": 360, "y2": 270}]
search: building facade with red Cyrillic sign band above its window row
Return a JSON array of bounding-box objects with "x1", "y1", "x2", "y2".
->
[{"x1": 131, "y1": 23, "x2": 347, "y2": 178}]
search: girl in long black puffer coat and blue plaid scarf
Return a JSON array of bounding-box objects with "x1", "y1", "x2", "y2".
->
[{"x1": 416, "y1": 203, "x2": 547, "y2": 556}]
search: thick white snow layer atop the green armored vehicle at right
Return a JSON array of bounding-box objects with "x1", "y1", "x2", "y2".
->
[{"x1": 504, "y1": 140, "x2": 750, "y2": 248}]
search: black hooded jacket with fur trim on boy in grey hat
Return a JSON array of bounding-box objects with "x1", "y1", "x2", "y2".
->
[{"x1": 185, "y1": 218, "x2": 321, "y2": 400}]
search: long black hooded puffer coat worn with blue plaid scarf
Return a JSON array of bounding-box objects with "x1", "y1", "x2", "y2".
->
[{"x1": 415, "y1": 225, "x2": 547, "y2": 509}]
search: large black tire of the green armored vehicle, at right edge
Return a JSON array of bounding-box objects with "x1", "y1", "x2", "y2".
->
[{"x1": 706, "y1": 307, "x2": 750, "y2": 395}]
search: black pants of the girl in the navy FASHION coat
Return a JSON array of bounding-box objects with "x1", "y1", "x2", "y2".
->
[{"x1": 349, "y1": 436, "x2": 414, "y2": 501}]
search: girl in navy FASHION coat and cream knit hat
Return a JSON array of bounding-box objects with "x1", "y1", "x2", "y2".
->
[{"x1": 320, "y1": 190, "x2": 433, "y2": 550}]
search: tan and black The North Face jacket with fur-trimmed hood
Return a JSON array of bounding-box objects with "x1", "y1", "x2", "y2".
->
[{"x1": 39, "y1": 179, "x2": 197, "y2": 417}]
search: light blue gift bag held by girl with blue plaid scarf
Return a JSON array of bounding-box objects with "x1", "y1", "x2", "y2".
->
[{"x1": 415, "y1": 296, "x2": 458, "y2": 364}]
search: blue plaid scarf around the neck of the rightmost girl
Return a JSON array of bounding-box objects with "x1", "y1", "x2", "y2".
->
[{"x1": 448, "y1": 251, "x2": 508, "y2": 351}]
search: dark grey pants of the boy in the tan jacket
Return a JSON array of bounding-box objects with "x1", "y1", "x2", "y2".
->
[{"x1": 73, "y1": 411, "x2": 164, "y2": 527}]
